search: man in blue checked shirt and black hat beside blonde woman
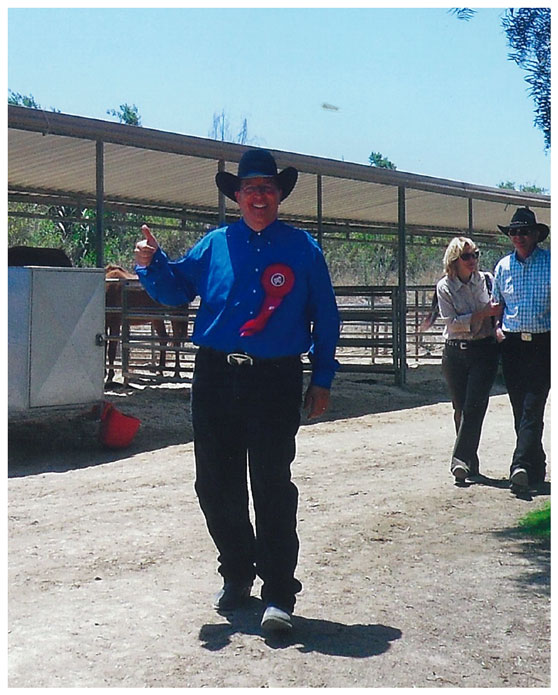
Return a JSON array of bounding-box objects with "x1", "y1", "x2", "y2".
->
[{"x1": 493, "y1": 208, "x2": 550, "y2": 494}]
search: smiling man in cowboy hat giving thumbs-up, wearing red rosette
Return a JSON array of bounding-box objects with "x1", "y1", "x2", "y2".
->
[{"x1": 136, "y1": 149, "x2": 339, "y2": 630}]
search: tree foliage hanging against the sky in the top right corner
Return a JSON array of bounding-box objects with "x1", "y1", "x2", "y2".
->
[{"x1": 450, "y1": 7, "x2": 551, "y2": 150}]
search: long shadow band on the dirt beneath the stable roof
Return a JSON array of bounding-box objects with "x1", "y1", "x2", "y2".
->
[{"x1": 8, "y1": 365, "x2": 504, "y2": 477}]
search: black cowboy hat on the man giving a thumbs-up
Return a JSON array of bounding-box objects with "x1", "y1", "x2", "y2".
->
[{"x1": 215, "y1": 149, "x2": 298, "y2": 203}]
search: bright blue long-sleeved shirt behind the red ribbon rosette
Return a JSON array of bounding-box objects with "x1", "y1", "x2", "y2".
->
[{"x1": 136, "y1": 219, "x2": 339, "y2": 388}]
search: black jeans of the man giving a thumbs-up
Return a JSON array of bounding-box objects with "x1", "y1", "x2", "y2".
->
[{"x1": 192, "y1": 348, "x2": 302, "y2": 611}]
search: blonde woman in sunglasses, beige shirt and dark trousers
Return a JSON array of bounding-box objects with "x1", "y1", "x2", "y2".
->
[{"x1": 436, "y1": 237, "x2": 501, "y2": 482}]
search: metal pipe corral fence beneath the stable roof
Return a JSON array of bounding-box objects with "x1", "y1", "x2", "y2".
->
[{"x1": 106, "y1": 280, "x2": 443, "y2": 385}]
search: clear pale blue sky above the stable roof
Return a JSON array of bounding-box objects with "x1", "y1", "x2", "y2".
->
[{"x1": 7, "y1": 5, "x2": 550, "y2": 189}]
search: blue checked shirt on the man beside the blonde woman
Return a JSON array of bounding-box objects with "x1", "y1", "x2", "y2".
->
[{"x1": 493, "y1": 246, "x2": 550, "y2": 333}]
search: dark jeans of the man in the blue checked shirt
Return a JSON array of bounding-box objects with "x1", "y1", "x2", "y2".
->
[{"x1": 502, "y1": 333, "x2": 550, "y2": 484}]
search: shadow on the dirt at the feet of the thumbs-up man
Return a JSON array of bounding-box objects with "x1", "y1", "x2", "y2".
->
[{"x1": 199, "y1": 597, "x2": 402, "y2": 659}]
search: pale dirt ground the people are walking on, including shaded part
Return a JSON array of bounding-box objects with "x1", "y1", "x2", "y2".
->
[{"x1": 8, "y1": 366, "x2": 550, "y2": 688}]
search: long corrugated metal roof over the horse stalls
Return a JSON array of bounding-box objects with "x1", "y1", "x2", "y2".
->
[{"x1": 8, "y1": 106, "x2": 550, "y2": 235}]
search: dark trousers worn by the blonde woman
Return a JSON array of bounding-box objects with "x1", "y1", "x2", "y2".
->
[{"x1": 442, "y1": 341, "x2": 499, "y2": 475}]
